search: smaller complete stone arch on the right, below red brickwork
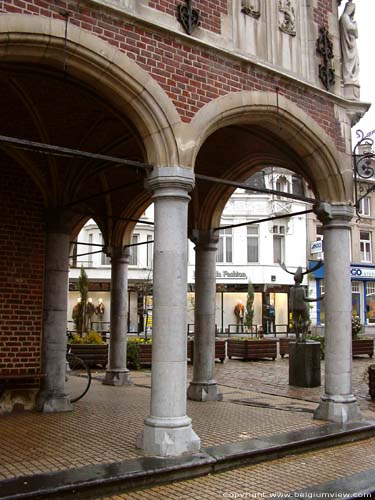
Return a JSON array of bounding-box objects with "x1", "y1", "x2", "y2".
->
[{"x1": 181, "y1": 92, "x2": 352, "y2": 218}]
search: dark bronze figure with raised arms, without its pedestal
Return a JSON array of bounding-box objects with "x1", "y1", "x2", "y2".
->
[{"x1": 279, "y1": 261, "x2": 324, "y2": 342}]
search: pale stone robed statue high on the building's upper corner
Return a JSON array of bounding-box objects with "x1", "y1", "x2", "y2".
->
[{"x1": 340, "y1": 0, "x2": 359, "y2": 87}]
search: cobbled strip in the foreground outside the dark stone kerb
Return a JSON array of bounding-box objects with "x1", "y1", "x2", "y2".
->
[{"x1": 98, "y1": 438, "x2": 375, "y2": 500}]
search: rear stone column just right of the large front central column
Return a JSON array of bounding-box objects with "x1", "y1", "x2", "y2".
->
[{"x1": 188, "y1": 230, "x2": 222, "y2": 401}]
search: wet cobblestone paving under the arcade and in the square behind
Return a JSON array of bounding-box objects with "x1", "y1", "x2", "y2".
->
[{"x1": 0, "y1": 358, "x2": 375, "y2": 484}]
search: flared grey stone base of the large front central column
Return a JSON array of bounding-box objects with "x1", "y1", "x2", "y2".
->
[{"x1": 137, "y1": 417, "x2": 200, "y2": 457}]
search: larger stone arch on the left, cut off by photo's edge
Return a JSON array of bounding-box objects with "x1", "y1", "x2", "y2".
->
[{"x1": 0, "y1": 14, "x2": 180, "y2": 165}]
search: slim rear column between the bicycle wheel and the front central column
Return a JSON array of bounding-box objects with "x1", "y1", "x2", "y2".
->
[{"x1": 103, "y1": 248, "x2": 131, "y2": 385}]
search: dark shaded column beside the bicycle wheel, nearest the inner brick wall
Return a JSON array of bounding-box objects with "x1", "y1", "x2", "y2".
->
[{"x1": 37, "y1": 210, "x2": 73, "y2": 413}]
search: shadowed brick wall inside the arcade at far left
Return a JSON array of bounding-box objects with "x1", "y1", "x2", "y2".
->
[{"x1": 0, "y1": 164, "x2": 44, "y2": 374}]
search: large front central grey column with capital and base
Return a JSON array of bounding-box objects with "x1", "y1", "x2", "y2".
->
[{"x1": 138, "y1": 167, "x2": 200, "y2": 457}]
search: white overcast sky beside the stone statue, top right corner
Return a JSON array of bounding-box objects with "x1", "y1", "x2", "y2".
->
[{"x1": 346, "y1": 0, "x2": 375, "y2": 140}]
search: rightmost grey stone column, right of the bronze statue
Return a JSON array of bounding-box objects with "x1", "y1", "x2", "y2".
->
[{"x1": 314, "y1": 203, "x2": 361, "y2": 423}]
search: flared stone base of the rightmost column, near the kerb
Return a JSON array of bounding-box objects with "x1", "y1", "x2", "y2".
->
[{"x1": 314, "y1": 395, "x2": 362, "y2": 424}]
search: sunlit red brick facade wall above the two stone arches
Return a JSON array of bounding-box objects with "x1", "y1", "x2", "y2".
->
[{"x1": 0, "y1": 0, "x2": 344, "y2": 150}]
